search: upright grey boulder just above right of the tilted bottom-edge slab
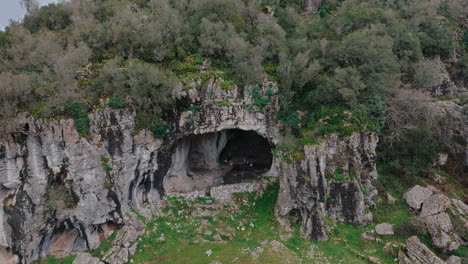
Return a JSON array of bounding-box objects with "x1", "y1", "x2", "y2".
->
[{"x1": 422, "y1": 213, "x2": 461, "y2": 252}]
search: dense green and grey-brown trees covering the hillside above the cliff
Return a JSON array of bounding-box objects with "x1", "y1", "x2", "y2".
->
[{"x1": 0, "y1": 0, "x2": 468, "y2": 180}]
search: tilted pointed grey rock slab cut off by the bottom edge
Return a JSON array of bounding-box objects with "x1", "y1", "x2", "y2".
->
[{"x1": 398, "y1": 236, "x2": 445, "y2": 264}]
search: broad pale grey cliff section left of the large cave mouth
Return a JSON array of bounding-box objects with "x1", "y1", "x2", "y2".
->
[{"x1": 0, "y1": 110, "x2": 163, "y2": 263}]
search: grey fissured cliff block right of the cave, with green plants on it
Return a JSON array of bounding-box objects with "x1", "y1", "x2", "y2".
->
[{"x1": 275, "y1": 133, "x2": 377, "y2": 240}]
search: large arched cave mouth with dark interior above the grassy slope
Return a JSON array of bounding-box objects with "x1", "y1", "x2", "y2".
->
[{"x1": 163, "y1": 129, "x2": 273, "y2": 193}]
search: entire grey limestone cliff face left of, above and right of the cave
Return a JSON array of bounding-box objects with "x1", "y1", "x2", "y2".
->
[{"x1": 0, "y1": 79, "x2": 377, "y2": 264}]
